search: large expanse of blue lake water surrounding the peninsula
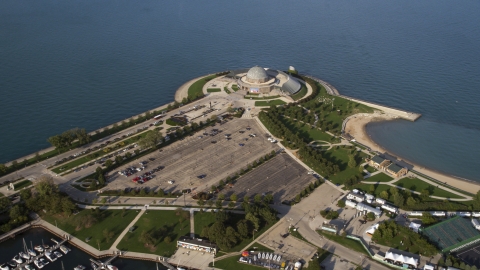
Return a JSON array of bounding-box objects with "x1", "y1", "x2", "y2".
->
[{"x1": 0, "y1": 0, "x2": 480, "y2": 181}]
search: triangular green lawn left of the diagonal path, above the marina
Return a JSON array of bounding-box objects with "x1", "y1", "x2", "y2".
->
[{"x1": 42, "y1": 209, "x2": 138, "y2": 250}]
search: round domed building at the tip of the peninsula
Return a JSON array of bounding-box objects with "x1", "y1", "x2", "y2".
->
[{"x1": 227, "y1": 66, "x2": 304, "y2": 95}]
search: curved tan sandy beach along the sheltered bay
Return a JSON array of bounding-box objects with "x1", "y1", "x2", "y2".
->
[{"x1": 345, "y1": 113, "x2": 480, "y2": 193}]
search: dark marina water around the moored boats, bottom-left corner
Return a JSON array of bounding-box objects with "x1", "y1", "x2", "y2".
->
[{"x1": 0, "y1": 229, "x2": 166, "y2": 270}]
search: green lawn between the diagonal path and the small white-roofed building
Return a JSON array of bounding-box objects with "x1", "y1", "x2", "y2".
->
[{"x1": 117, "y1": 210, "x2": 190, "y2": 257}]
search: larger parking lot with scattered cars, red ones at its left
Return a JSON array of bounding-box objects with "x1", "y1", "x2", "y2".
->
[{"x1": 109, "y1": 118, "x2": 279, "y2": 192}]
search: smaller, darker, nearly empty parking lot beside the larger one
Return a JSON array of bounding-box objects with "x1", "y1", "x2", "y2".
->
[{"x1": 218, "y1": 154, "x2": 316, "y2": 204}]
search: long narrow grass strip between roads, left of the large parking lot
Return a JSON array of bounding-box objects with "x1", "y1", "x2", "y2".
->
[{"x1": 52, "y1": 131, "x2": 151, "y2": 174}]
